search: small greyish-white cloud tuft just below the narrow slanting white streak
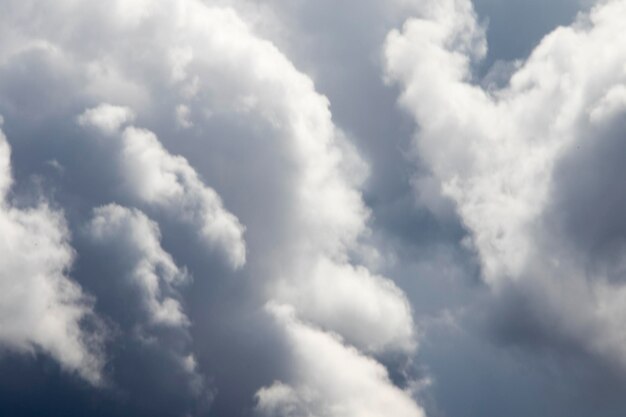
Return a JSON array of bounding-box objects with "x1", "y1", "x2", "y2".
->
[{"x1": 84, "y1": 204, "x2": 207, "y2": 399}]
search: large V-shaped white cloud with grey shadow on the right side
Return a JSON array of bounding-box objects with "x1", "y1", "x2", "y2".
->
[{"x1": 385, "y1": 0, "x2": 626, "y2": 367}]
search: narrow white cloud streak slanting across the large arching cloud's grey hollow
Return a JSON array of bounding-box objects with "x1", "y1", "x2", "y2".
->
[{"x1": 79, "y1": 105, "x2": 246, "y2": 267}]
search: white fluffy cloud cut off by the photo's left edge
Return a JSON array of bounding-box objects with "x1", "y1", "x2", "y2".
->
[{"x1": 0, "y1": 121, "x2": 103, "y2": 384}]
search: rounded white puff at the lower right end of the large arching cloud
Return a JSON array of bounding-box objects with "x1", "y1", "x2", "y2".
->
[{"x1": 279, "y1": 258, "x2": 416, "y2": 353}]
